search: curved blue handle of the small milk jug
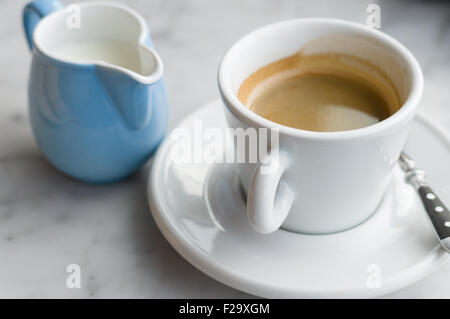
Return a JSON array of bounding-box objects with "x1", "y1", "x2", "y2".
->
[{"x1": 23, "y1": 0, "x2": 63, "y2": 49}]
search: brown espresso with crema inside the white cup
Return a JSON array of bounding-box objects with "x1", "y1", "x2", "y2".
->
[{"x1": 238, "y1": 53, "x2": 400, "y2": 132}]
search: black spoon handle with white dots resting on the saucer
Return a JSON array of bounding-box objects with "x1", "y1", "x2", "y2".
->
[{"x1": 417, "y1": 185, "x2": 450, "y2": 252}]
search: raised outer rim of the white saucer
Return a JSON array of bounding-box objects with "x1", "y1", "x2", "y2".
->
[{"x1": 147, "y1": 99, "x2": 450, "y2": 298}]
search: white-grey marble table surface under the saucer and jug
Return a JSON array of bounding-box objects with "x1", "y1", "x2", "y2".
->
[{"x1": 0, "y1": 0, "x2": 450, "y2": 298}]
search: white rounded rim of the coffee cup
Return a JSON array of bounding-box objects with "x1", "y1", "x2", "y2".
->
[{"x1": 217, "y1": 18, "x2": 423, "y2": 140}]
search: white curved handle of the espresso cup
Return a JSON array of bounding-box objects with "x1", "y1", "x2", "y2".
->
[{"x1": 247, "y1": 151, "x2": 295, "y2": 234}]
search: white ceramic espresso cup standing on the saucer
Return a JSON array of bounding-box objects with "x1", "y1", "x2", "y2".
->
[{"x1": 218, "y1": 18, "x2": 423, "y2": 234}]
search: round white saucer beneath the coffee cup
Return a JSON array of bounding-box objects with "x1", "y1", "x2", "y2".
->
[{"x1": 148, "y1": 101, "x2": 450, "y2": 298}]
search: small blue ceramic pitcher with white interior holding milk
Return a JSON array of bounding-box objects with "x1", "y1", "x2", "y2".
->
[{"x1": 23, "y1": 0, "x2": 168, "y2": 183}]
